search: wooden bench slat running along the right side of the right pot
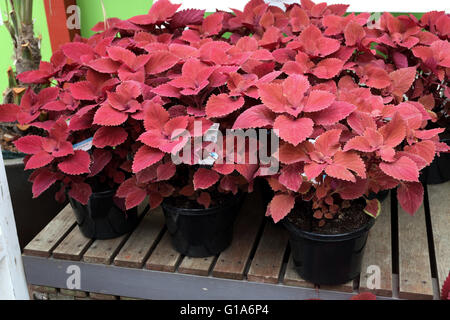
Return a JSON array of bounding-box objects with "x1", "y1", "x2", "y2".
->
[{"x1": 360, "y1": 196, "x2": 392, "y2": 297}]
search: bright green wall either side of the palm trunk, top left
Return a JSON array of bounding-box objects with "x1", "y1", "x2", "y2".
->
[{"x1": 0, "y1": 0, "x2": 51, "y2": 96}]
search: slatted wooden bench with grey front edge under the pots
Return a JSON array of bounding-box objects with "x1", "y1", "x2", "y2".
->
[{"x1": 23, "y1": 183, "x2": 450, "y2": 300}]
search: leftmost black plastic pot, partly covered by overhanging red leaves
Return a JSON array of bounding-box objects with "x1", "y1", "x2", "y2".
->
[{"x1": 69, "y1": 190, "x2": 138, "y2": 240}]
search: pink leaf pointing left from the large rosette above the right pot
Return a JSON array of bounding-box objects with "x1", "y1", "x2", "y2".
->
[{"x1": 233, "y1": 104, "x2": 275, "y2": 129}]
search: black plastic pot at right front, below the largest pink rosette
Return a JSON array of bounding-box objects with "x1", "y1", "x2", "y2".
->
[{"x1": 283, "y1": 215, "x2": 375, "y2": 285}]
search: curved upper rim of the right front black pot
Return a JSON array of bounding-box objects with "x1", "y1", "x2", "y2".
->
[{"x1": 282, "y1": 218, "x2": 376, "y2": 242}]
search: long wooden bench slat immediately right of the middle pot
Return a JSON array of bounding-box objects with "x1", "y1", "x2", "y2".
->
[{"x1": 213, "y1": 192, "x2": 264, "y2": 280}]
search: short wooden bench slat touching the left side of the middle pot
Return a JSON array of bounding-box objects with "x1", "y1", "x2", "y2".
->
[{"x1": 145, "y1": 232, "x2": 181, "y2": 272}]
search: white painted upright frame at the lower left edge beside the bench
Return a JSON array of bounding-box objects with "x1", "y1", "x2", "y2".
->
[{"x1": 0, "y1": 148, "x2": 30, "y2": 300}]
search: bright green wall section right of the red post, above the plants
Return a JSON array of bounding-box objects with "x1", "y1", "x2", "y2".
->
[{"x1": 77, "y1": 0, "x2": 153, "y2": 37}]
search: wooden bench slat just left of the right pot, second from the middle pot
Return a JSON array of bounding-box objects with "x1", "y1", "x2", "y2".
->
[{"x1": 247, "y1": 221, "x2": 289, "y2": 283}]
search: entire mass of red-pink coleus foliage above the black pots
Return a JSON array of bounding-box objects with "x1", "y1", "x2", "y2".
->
[{"x1": 0, "y1": 0, "x2": 450, "y2": 225}]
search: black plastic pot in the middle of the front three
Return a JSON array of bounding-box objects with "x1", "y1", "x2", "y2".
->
[{"x1": 162, "y1": 195, "x2": 244, "y2": 258}]
